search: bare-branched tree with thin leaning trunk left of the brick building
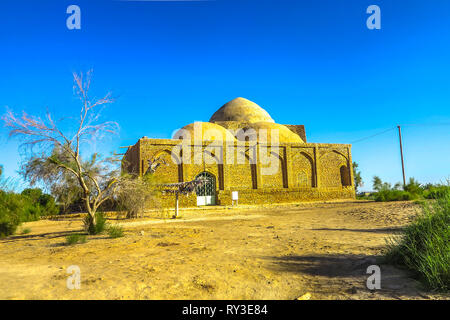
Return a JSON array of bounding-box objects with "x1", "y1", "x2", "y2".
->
[{"x1": 2, "y1": 72, "x2": 119, "y2": 230}]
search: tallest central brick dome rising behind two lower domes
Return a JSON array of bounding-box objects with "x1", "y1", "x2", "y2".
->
[{"x1": 209, "y1": 98, "x2": 275, "y2": 123}]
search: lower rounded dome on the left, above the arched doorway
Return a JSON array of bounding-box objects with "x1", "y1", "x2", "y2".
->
[{"x1": 173, "y1": 122, "x2": 236, "y2": 141}]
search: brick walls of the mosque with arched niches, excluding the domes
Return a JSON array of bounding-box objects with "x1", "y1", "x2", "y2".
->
[{"x1": 122, "y1": 100, "x2": 355, "y2": 207}]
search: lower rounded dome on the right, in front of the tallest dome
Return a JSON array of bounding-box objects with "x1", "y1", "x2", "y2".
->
[{"x1": 238, "y1": 122, "x2": 304, "y2": 143}]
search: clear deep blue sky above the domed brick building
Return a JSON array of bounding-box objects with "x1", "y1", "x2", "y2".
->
[{"x1": 0, "y1": 0, "x2": 450, "y2": 190}]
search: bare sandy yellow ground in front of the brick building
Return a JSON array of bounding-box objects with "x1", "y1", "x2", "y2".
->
[{"x1": 0, "y1": 202, "x2": 448, "y2": 300}]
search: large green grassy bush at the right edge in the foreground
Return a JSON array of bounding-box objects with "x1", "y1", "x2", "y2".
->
[{"x1": 386, "y1": 186, "x2": 450, "y2": 291}]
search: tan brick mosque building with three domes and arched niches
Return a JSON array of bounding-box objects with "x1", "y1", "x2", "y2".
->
[{"x1": 122, "y1": 98, "x2": 355, "y2": 207}]
